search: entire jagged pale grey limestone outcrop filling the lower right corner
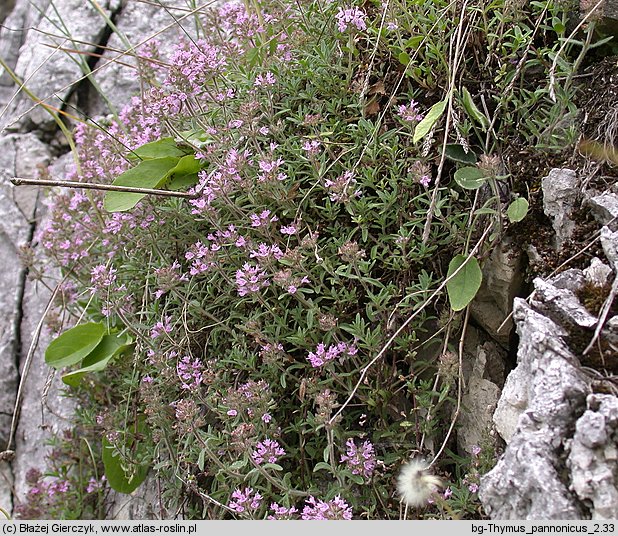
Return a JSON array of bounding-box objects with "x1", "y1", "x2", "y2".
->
[{"x1": 480, "y1": 228, "x2": 618, "y2": 519}]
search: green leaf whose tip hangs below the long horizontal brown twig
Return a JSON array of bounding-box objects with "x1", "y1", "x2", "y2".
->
[{"x1": 103, "y1": 156, "x2": 178, "y2": 212}]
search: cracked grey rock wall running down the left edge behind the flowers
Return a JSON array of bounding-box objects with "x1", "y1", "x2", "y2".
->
[{"x1": 0, "y1": 0, "x2": 191, "y2": 518}]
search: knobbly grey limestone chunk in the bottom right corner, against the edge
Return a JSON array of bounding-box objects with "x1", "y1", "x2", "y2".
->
[{"x1": 567, "y1": 394, "x2": 618, "y2": 519}]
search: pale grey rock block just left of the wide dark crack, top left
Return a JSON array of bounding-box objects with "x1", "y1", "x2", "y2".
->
[{"x1": 3, "y1": 0, "x2": 120, "y2": 129}]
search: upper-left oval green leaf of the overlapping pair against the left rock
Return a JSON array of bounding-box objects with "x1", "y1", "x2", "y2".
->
[{"x1": 45, "y1": 322, "x2": 105, "y2": 369}]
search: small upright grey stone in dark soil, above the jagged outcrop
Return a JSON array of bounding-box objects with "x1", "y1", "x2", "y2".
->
[{"x1": 541, "y1": 169, "x2": 580, "y2": 249}]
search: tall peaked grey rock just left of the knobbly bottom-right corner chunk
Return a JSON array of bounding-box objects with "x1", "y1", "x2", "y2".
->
[{"x1": 480, "y1": 299, "x2": 588, "y2": 519}]
